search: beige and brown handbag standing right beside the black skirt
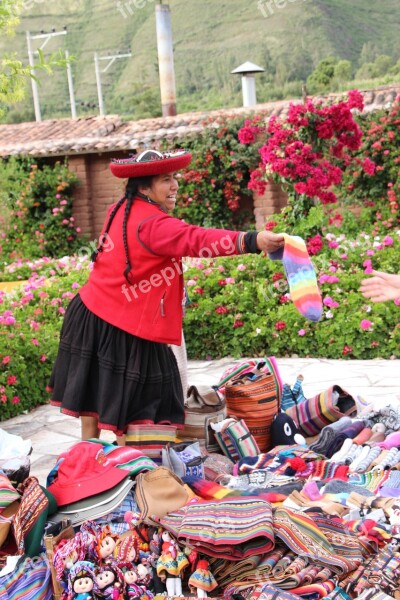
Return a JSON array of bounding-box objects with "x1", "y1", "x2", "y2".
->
[{"x1": 178, "y1": 385, "x2": 226, "y2": 452}]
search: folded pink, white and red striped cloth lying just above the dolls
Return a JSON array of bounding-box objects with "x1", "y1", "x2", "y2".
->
[{"x1": 157, "y1": 496, "x2": 275, "y2": 561}]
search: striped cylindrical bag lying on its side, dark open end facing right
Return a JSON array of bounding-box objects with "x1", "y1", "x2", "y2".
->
[{"x1": 286, "y1": 385, "x2": 357, "y2": 436}]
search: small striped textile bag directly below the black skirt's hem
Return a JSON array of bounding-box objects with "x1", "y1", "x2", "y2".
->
[{"x1": 125, "y1": 423, "x2": 176, "y2": 466}]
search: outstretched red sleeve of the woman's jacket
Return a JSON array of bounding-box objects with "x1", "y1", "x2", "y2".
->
[{"x1": 137, "y1": 214, "x2": 245, "y2": 258}]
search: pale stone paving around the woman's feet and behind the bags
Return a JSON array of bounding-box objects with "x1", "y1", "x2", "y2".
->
[{"x1": 0, "y1": 358, "x2": 400, "y2": 485}]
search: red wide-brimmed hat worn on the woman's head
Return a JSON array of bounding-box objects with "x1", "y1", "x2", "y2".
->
[{"x1": 110, "y1": 150, "x2": 192, "y2": 179}]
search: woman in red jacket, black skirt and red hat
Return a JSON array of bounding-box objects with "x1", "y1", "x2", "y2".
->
[{"x1": 49, "y1": 150, "x2": 284, "y2": 440}]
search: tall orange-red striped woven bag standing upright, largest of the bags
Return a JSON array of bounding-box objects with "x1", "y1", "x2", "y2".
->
[{"x1": 225, "y1": 359, "x2": 282, "y2": 452}]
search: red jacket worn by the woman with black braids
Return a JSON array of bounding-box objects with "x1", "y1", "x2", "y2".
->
[{"x1": 79, "y1": 198, "x2": 245, "y2": 345}]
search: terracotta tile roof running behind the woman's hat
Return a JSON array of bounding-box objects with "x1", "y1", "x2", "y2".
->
[{"x1": 0, "y1": 85, "x2": 400, "y2": 157}]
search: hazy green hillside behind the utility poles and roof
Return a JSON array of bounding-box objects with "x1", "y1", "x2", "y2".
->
[{"x1": 0, "y1": 0, "x2": 400, "y2": 120}]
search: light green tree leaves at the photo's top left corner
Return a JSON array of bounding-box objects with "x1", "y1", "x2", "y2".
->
[{"x1": 0, "y1": 0, "x2": 73, "y2": 118}]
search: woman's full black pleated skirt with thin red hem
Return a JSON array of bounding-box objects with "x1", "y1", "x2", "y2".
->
[{"x1": 48, "y1": 294, "x2": 184, "y2": 435}]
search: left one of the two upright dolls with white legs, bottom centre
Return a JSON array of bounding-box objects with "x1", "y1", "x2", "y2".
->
[{"x1": 157, "y1": 531, "x2": 189, "y2": 596}]
